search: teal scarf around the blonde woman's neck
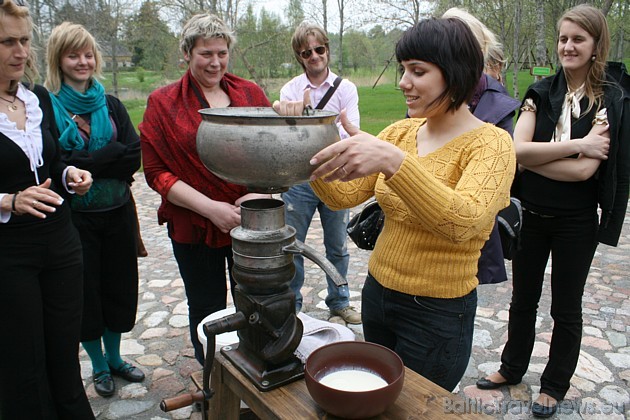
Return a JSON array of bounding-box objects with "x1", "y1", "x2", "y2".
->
[{"x1": 50, "y1": 79, "x2": 113, "y2": 152}]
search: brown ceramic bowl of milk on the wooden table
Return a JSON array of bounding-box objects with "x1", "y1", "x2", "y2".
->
[{"x1": 304, "y1": 341, "x2": 405, "y2": 419}]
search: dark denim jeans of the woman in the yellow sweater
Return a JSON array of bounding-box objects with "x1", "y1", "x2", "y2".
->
[{"x1": 361, "y1": 273, "x2": 477, "y2": 391}]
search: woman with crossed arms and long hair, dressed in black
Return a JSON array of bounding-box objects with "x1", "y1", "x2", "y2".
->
[{"x1": 477, "y1": 5, "x2": 630, "y2": 417}]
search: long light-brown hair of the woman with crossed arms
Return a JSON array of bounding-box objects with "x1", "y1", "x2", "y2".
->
[{"x1": 557, "y1": 4, "x2": 610, "y2": 112}]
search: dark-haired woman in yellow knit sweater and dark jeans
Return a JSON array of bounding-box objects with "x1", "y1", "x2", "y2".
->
[{"x1": 275, "y1": 19, "x2": 515, "y2": 390}]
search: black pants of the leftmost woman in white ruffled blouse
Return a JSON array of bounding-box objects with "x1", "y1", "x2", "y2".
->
[{"x1": 0, "y1": 223, "x2": 94, "y2": 420}]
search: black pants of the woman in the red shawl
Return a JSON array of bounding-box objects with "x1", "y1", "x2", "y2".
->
[{"x1": 171, "y1": 240, "x2": 236, "y2": 365}]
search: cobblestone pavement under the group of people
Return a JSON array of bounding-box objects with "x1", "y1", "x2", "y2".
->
[{"x1": 80, "y1": 174, "x2": 630, "y2": 420}]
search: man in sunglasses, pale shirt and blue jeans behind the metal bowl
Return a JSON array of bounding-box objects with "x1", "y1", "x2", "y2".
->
[{"x1": 280, "y1": 22, "x2": 361, "y2": 324}]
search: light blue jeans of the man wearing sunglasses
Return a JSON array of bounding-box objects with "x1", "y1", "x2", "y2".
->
[{"x1": 282, "y1": 183, "x2": 350, "y2": 311}]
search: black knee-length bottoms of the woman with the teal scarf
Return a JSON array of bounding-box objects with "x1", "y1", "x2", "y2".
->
[{"x1": 72, "y1": 200, "x2": 138, "y2": 341}]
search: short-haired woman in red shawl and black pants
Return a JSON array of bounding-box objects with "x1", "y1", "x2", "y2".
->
[{"x1": 139, "y1": 14, "x2": 270, "y2": 364}]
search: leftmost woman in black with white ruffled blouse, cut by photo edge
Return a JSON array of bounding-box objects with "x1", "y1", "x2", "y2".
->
[{"x1": 0, "y1": 0, "x2": 94, "y2": 420}]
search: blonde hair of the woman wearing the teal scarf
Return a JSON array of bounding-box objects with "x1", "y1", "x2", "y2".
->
[{"x1": 44, "y1": 22, "x2": 103, "y2": 93}]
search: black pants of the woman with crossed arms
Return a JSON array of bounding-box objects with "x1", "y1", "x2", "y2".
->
[{"x1": 499, "y1": 210, "x2": 597, "y2": 400}]
